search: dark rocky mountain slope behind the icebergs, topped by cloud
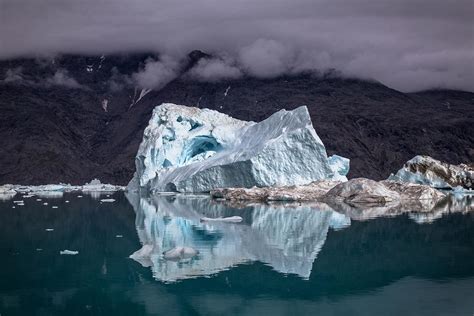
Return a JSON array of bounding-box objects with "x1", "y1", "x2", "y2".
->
[{"x1": 0, "y1": 52, "x2": 474, "y2": 184}]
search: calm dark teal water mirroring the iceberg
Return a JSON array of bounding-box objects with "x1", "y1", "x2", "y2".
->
[{"x1": 0, "y1": 193, "x2": 474, "y2": 316}]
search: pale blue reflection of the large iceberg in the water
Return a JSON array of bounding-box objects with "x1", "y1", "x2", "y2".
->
[{"x1": 127, "y1": 194, "x2": 350, "y2": 282}]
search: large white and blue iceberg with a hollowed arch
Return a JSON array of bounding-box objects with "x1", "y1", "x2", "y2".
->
[{"x1": 128, "y1": 103, "x2": 349, "y2": 192}]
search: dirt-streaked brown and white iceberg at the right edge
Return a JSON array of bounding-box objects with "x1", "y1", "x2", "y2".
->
[{"x1": 388, "y1": 156, "x2": 474, "y2": 191}]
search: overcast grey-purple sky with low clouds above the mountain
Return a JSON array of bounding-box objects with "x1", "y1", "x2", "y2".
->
[{"x1": 0, "y1": 0, "x2": 474, "y2": 91}]
